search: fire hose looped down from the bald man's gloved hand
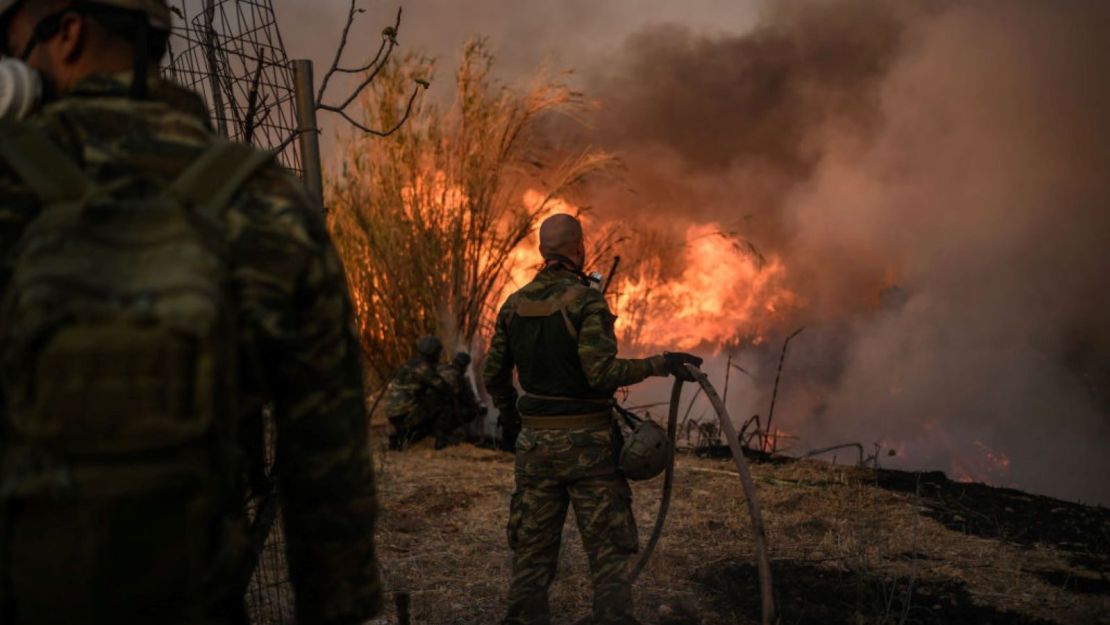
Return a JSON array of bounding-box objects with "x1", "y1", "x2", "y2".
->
[{"x1": 576, "y1": 364, "x2": 775, "y2": 625}]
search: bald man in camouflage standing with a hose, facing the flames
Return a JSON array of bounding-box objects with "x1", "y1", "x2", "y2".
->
[{"x1": 483, "y1": 215, "x2": 702, "y2": 625}]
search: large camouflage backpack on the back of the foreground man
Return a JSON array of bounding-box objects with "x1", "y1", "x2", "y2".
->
[{"x1": 0, "y1": 125, "x2": 272, "y2": 624}]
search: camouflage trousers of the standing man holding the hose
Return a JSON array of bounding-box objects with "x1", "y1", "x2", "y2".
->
[{"x1": 504, "y1": 429, "x2": 639, "y2": 625}]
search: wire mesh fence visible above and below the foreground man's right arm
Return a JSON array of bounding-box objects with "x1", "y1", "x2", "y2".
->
[{"x1": 162, "y1": 0, "x2": 302, "y2": 625}]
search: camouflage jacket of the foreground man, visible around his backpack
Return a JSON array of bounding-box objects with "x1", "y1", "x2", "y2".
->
[{"x1": 0, "y1": 74, "x2": 382, "y2": 623}]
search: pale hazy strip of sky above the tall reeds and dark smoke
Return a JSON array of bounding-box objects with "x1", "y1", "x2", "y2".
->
[{"x1": 271, "y1": 0, "x2": 759, "y2": 159}]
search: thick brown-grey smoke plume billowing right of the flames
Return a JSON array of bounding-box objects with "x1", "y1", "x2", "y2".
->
[{"x1": 577, "y1": 0, "x2": 1110, "y2": 503}]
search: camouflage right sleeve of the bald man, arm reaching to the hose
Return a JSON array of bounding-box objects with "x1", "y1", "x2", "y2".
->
[{"x1": 578, "y1": 290, "x2": 666, "y2": 390}]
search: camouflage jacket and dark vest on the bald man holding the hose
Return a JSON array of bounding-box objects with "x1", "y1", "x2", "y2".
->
[{"x1": 482, "y1": 265, "x2": 666, "y2": 415}]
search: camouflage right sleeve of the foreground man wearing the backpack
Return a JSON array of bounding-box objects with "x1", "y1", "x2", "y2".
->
[{"x1": 231, "y1": 166, "x2": 382, "y2": 624}]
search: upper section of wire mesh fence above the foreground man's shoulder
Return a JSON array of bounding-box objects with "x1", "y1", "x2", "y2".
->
[{"x1": 163, "y1": 0, "x2": 301, "y2": 173}]
